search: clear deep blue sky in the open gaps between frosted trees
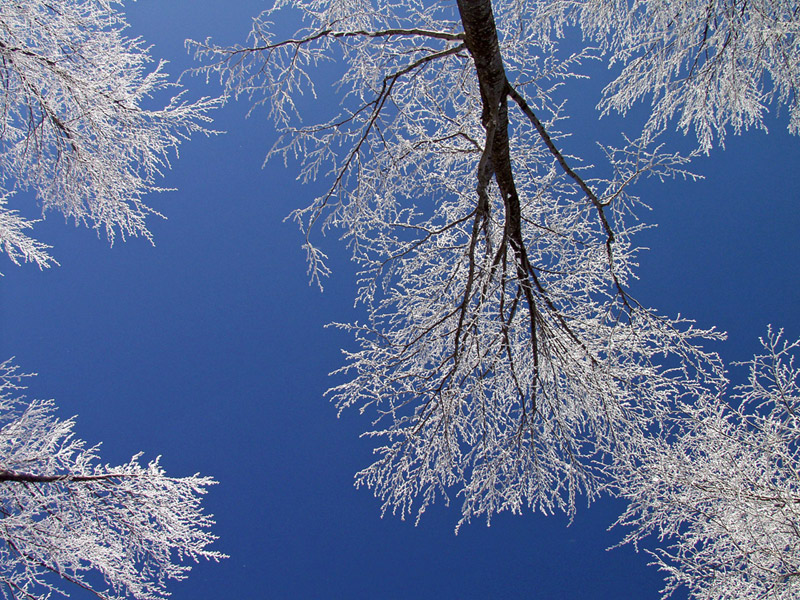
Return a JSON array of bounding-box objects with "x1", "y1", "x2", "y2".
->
[{"x1": 0, "y1": 0, "x2": 800, "y2": 600}]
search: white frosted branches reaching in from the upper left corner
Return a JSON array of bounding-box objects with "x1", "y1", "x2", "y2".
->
[{"x1": 0, "y1": 0, "x2": 214, "y2": 267}]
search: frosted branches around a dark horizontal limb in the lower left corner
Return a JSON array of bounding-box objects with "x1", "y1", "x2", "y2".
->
[{"x1": 0, "y1": 361, "x2": 223, "y2": 600}]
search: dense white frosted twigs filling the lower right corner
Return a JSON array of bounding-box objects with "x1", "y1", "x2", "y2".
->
[{"x1": 620, "y1": 332, "x2": 800, "y2": 600}]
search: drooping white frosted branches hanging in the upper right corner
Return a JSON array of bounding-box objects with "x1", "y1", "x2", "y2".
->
[{"x1": 572, "y1": 0, "x2": 800, "y2": 152}]
